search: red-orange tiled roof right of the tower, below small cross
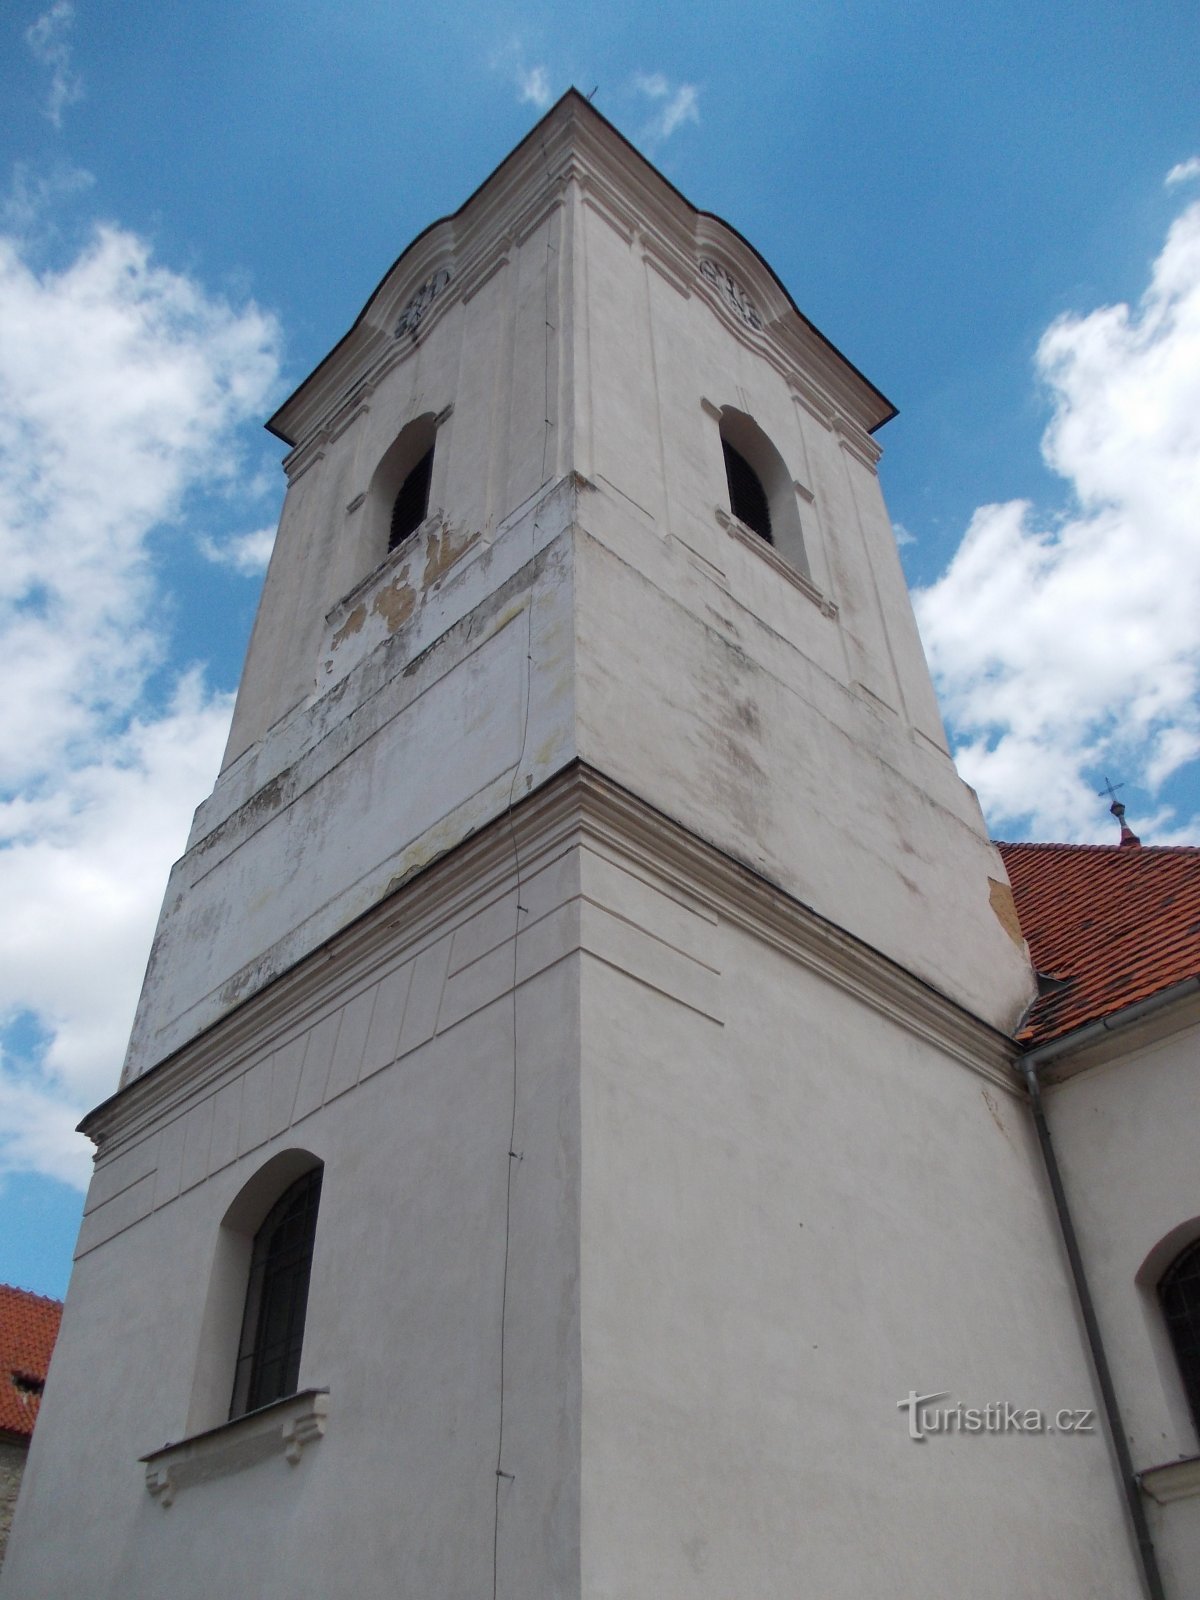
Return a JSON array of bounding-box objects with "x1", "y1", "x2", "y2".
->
[{"x1": 998, "y1": 845, "x2": 1200, "y2": 1043}]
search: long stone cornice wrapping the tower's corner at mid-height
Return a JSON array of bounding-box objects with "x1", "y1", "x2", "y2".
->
[{"x1": 80, "y1": 762, "x2": 1016, "y2": 1154}]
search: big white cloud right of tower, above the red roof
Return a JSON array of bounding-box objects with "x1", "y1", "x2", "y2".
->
[{"x1": 915, "y1": 196, "x2": 1200, "y2": 838}]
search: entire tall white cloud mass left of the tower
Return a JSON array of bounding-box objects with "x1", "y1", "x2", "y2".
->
[{"x1": 0, "y1": 212, "x2": 278, "y2": 1182}]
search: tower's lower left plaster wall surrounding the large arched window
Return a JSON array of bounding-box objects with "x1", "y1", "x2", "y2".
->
[{"x1": 0, "y1": 854, "x2": 579, "y2": 1600}]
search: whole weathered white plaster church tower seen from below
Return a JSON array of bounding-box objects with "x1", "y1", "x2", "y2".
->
[{"x1": 0, "y1": 93, "x2": 1136, "y2": 1600}]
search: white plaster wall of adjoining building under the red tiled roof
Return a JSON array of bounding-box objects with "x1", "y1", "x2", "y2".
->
[{"x1": 1045, "y1": 1000, "x2": 1200, "y2": 1600}]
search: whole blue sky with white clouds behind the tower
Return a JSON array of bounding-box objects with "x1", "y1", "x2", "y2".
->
[{"x1": 0, "y1": 0, "x2": 1200, "y2": 1294}]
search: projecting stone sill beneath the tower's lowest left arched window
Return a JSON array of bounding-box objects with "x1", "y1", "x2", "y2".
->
[{"x1": 139, "y1": 1389, "x2": 330, "y2": 1507}]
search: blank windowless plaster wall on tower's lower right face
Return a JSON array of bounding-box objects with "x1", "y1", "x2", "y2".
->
[{"x1": 581, "y1": 854, "x2": 1139, "y2": 1600}]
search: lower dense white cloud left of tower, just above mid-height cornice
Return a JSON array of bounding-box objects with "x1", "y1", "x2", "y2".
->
[{"x1": 0, "y1": 674, "x2": 230, "y2": 1187}]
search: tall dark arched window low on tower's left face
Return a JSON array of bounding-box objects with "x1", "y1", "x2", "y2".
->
[{"x1": 229, "y1": 1166, "x2": 322, "y2": 1418}]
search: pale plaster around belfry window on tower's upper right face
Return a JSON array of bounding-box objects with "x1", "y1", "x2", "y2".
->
[{"x1": 574, "y1": 180, "x2": 944, "y2": 747}]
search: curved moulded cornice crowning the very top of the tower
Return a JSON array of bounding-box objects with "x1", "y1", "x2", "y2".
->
[{"x1": 267, "y1": 88, "x2": 896, "y2": 446}]
